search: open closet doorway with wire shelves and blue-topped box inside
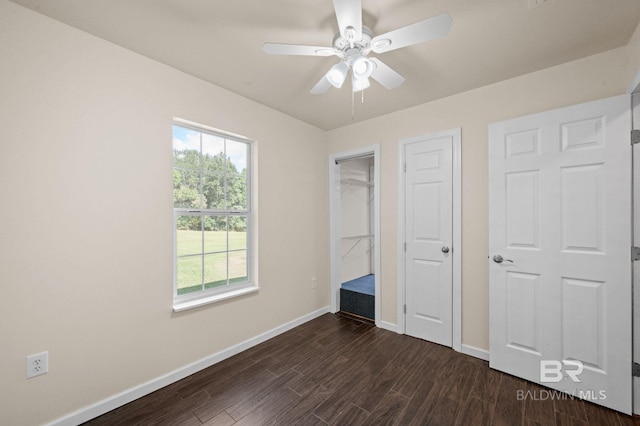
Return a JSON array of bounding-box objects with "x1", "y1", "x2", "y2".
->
[{"x1": 330, "y1": 147, "x2": 380, "y2": 323}]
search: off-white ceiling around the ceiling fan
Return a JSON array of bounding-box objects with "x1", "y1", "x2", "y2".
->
[{"x1": 13, "y1": 0, "x2": 640, "y2": 130}]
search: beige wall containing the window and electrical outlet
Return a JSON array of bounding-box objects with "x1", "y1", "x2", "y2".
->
[{"x1": 0, "y1": 0, "x2": 329, "y2": 425}]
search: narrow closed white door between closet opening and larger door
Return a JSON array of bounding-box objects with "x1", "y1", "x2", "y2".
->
[{"x1": 404, "y1": 135, "x2": 454, "y2": 346}]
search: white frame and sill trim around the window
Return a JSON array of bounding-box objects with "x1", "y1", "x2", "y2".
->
[{"x1": 172, "y1": 117, "x2": 260, "y2": 312}]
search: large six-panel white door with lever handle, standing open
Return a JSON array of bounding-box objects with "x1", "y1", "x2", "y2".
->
[{"x1": 489, "y1": 96, "x2": 631, "y2": 413}]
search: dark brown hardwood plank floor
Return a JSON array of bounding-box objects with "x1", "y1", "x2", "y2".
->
[{"x1": 82, "y1": 314, "x2": 640, "y2": 426}]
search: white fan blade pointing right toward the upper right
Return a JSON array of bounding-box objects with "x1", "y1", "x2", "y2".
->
[{"x1": 371, "y1": 13, "x2": 453, "y2": 53}]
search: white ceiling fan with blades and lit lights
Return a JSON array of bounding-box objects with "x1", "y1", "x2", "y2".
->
[{"x1": 262, "y1": 0, "x2": 452, "y2": 95}]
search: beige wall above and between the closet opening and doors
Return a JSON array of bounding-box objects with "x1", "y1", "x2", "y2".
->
[{"x1": 328, "y1": 48, "x2": 633, "y2": 349}]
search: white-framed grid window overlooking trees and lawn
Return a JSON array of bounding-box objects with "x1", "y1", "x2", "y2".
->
[{"x1": 173, "y1": 120, "x2": 256, "y2": 310}]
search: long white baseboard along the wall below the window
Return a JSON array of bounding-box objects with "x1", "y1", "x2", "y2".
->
[{"x1": 49, "y1": 306, "x2": 329, "y2": 426}]
